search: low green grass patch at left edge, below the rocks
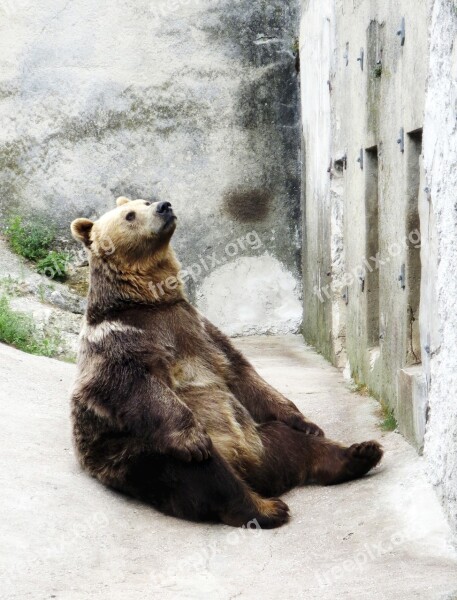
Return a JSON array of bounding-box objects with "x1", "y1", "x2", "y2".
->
[{"x1": 0, "y1": 295, "x2": 60, "y2": 357}]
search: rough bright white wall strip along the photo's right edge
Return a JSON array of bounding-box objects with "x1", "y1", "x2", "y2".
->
[{"x1": 420, "y1": 0, "x2": 457, "y2": 540}]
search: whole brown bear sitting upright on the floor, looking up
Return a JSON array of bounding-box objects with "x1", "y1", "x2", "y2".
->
[{"x1": 71, "y1": 198, "x2": 382, "y2": 528}]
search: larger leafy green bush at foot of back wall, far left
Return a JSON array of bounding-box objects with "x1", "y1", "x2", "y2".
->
[{"x1": 5, "y1": 216, "x2": 55, "y2": 262}]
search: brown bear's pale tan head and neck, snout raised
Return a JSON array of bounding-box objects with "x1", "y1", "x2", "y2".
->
[{"x1": 71, "y1": 197, "x2": 182, "y2": 312}]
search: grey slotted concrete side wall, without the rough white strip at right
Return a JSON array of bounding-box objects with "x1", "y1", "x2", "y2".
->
[{"x1": 301, "y1": 0, "x2": 429, "y2": 422}]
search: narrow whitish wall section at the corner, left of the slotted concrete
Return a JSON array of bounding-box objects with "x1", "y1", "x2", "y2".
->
[{"x1": 300, "y1": 0, "x2": 336, "y2": 361}]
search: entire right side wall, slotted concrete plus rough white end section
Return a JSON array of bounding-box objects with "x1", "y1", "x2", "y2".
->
[{"x1": 300, "y1": 0, "x2": 457, "y2": 536}]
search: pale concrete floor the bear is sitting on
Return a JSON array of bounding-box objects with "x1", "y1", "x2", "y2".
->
[{"x1": 0, "y1": 336, "x2": 457, "y2": 600}]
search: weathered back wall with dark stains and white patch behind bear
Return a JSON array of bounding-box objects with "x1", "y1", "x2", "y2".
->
[{"x1": 0, "y1": 0, "x2": 301, "y2": 334}]
